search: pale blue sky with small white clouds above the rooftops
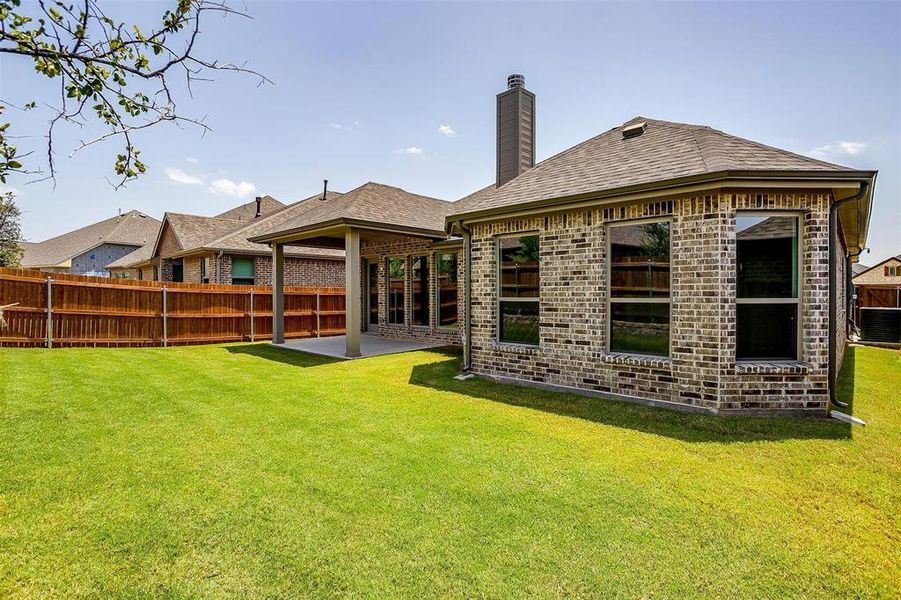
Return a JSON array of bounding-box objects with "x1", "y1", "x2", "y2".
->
[{"x1": 0, "y1": 1, "x2": 901, "y2": 264}]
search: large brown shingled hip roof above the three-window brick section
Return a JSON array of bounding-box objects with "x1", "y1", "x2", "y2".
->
[{"x1": 454, "y1": 117, "x2": 868, "y2": 215}]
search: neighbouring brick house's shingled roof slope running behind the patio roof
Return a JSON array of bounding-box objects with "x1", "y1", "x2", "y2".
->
[{"x1": 186, "y1": 192, "x2": 344, "y2": 259}]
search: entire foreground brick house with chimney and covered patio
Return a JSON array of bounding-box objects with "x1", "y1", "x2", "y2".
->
[{"x1": 250, "y1": 76, "x2": 876, "y2": 415}]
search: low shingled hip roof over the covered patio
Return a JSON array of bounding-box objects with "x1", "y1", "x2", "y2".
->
[{"x1": 250, "y1": 182, "x2": 454, "y2": 241}]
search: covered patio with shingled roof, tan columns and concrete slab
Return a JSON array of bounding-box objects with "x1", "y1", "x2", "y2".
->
[{"x1": 250, "y1": 183, "x2": 460, "y2": 358}]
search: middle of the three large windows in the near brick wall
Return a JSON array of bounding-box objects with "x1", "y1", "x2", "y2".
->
[{"x1": 608, "y1": 221, "x2": 672, "y2": 356}]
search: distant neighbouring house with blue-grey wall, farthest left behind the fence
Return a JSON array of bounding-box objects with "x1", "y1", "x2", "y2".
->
[{"x1": 22, "y1": 210, "x2": 160, "y2": 277}]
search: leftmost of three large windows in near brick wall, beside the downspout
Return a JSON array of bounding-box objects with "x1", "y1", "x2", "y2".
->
[{"x1": 497, "y1": 235, "x2": 539, "y2": 346}]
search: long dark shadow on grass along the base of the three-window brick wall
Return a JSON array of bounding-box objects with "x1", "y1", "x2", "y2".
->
[{"x1": 410, "y1": 351, "x2": 854, "y2": 444}]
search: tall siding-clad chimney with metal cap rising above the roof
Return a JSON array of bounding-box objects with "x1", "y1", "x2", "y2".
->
[{"x1": 495, "y1": 74, "x2": 535, "y2": 187}]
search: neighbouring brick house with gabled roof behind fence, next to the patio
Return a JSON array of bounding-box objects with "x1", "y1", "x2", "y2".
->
[{"x1": 110, "y1": 192, "x2": 344, "y2": 287}]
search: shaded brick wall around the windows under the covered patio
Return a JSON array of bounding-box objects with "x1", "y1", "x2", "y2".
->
[{"x1": 358, "y1": 236, "x2": 464, "y2": 345}]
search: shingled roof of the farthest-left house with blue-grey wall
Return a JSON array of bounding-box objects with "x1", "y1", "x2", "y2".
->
[{"x1": 22, "y1": 210, "x2": 160, "y2": 267}]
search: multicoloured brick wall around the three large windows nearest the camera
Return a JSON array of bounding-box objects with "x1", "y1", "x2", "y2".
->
[{"x1": 472, "y1": 191, "x2": 831, "y2": 414}]
